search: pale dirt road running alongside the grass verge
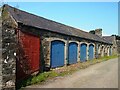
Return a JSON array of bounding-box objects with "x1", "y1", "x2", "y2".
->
[{"x1": 25, "y1": 59, "x2": 118, "y2": 88}]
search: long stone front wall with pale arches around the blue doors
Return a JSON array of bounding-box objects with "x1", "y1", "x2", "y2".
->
[{"x1": 20, "y1": 26, "x2": 109, "y2": 70}]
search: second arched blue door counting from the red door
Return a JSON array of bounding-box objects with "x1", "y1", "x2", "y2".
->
[{"x1": 68, "y1": 42, "x2": 77, "y2": 64}]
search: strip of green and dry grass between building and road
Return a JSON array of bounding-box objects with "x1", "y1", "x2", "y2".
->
[{"x1": 17, "y1": 55, "x2": 118, "y2": 88}]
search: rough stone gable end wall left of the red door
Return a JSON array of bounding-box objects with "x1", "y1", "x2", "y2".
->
[{"x1": 1, "y1": 5, "x2": 18, "y2": 90}]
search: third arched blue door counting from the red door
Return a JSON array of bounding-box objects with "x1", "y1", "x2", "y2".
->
[{"x1": 80, "y1": 43, "x2": 87, "y2": 62}]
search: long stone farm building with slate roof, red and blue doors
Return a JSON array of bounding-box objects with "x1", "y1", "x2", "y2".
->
[{"x1": 2, "y1": 5, "x2": 117, "y2": 89}]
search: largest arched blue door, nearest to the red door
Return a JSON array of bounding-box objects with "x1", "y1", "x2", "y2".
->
[{"x1": 50, "y1": 41, "x2": 64, "y2": 68}]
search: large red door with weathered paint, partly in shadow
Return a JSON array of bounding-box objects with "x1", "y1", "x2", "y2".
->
[{"x1": 17, "y1": 31, "x2": 40, "y2": 79}]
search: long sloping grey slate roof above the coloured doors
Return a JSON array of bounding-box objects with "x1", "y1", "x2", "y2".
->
[{"x1": 3, "y1": 4, "x2": 111, "y2": 44}]
